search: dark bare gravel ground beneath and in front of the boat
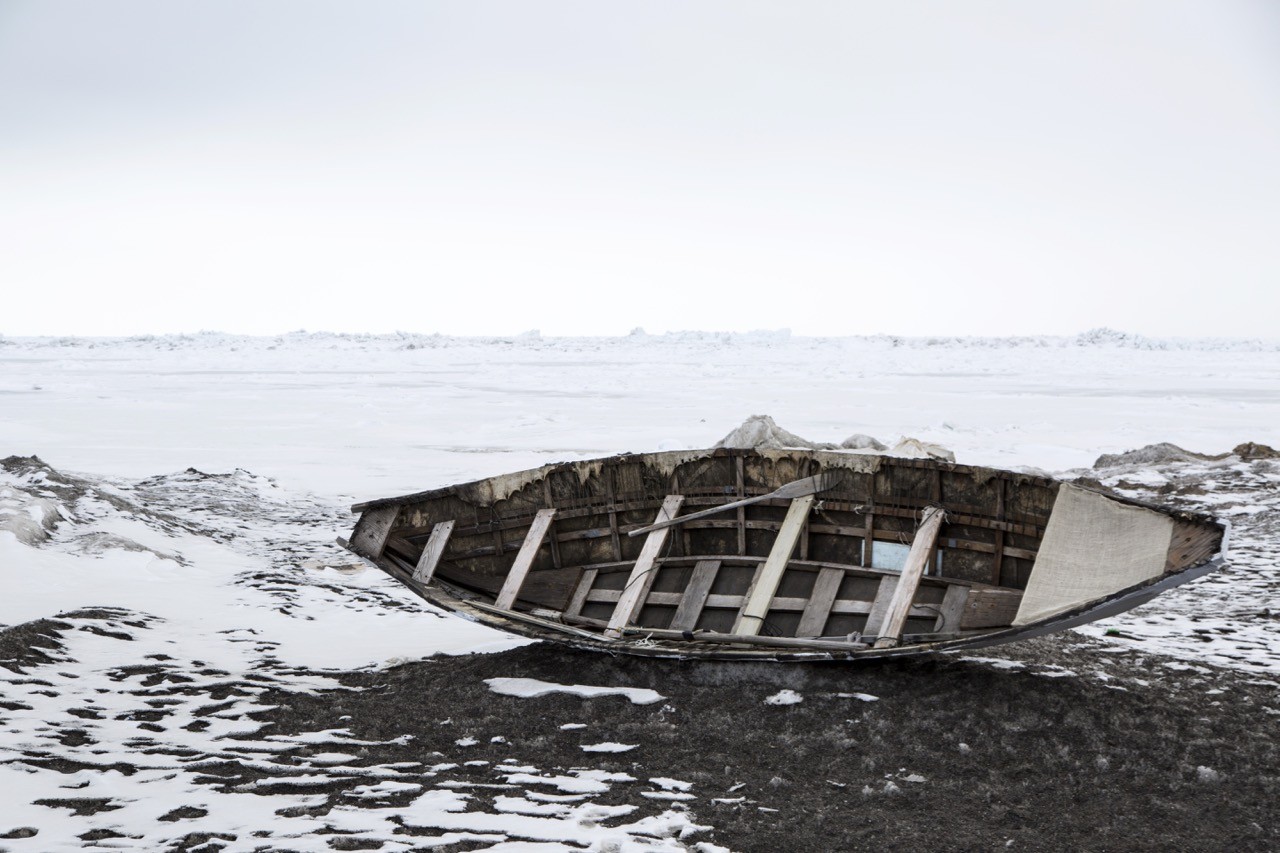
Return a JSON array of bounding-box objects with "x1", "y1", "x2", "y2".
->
[{"x1": 237, "y1": 635, "x2": 1280, "y2": 852}]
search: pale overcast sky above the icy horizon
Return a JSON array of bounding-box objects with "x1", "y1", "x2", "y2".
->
[{"x1": 0, "y1": 0, "x2": 1280, "y2": 338}]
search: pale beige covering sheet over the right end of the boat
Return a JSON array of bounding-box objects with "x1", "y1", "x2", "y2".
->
[{"x1": 1014, "y1": 483, "x2": 1174, "y2": 625}]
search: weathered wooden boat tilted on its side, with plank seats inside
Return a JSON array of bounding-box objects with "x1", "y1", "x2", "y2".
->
[{"x1": 339, "y1": 448, "x2": 1225, "y2": 660}]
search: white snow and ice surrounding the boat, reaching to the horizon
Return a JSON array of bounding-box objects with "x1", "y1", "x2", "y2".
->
[{"x1": 0, "y1": 330, "x2": 1280, "y2": 852}]
